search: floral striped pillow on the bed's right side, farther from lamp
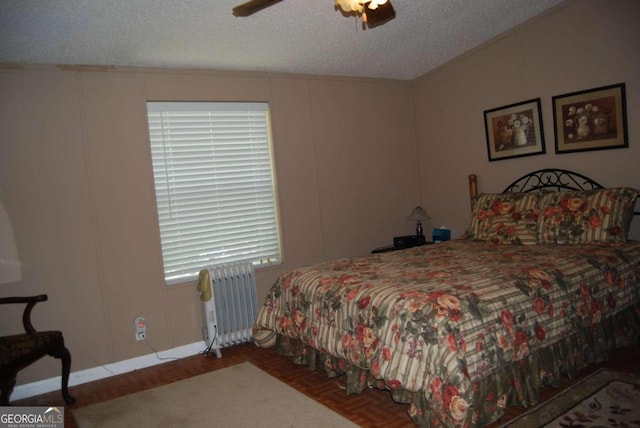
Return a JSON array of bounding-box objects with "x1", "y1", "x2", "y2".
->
[{"x1": 537, "y1": 188, "x2": 638, "y2": 244}]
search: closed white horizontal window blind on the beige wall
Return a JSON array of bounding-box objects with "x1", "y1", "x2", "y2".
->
[{"x1": 147, "y1": 102, "x2": 281, "y2": 284}]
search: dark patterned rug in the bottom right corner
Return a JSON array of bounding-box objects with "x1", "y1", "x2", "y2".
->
[{"x1": 501, "y1": 369, "x2": 640, "y2": 428}]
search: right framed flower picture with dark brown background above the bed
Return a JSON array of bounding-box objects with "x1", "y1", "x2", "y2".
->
[{"x1": 553, "y1": 83, "x2": 629, "y2": 154}]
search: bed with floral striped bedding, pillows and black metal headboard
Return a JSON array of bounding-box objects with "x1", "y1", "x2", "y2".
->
[{"x1": 254, "y1": 169, "x2": 640, "y2": 427}]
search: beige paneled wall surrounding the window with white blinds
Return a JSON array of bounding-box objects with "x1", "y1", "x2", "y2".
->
[{"x1": 0, "y1": 66, "x2": 419, "y2": 385}]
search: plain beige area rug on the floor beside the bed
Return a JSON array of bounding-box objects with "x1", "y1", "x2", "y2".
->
[{"x1": 72, "y1": 362, "x2": 357, "y2": 428}]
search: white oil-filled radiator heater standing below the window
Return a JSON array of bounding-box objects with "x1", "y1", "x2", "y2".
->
[{"x1": 198, "y1": 262, "x2": 258, "y2": 358}]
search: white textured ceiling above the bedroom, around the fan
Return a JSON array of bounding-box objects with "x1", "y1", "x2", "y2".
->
[{"x1": 0, "y1": 0, "x2": 566, "y2": 79}]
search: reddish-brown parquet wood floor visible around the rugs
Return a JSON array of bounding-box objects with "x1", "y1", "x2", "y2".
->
[{"x1": 12, "y1": 344, "x2": 640, "y2": 428}]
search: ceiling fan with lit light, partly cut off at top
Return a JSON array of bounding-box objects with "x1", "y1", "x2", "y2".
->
[{"x1": 233, "y1": 0, "x2": 396, "y2": 28}]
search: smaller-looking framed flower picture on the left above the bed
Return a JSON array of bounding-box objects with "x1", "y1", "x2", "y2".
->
[{"x1": 484, "y1": 98, "x2": 545, "y2": 161}]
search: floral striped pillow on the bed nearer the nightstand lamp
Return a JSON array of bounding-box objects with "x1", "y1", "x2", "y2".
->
[{"x1": 466, "y1": 193, "x2": 541, "y2": 245}]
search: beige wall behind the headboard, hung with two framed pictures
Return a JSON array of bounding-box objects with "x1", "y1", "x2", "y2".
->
[{"x1": 414, "y1": 0, "x2": 640, "y2": 239}]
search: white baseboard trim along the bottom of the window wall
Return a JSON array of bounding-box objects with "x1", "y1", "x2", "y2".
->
[{"x1": 11, "y1": 341, "x2": 206, "y2": 401}]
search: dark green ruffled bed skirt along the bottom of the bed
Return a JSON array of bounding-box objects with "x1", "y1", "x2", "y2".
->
[{"x1": 268, "y1": 307, "x2": 640, "y2": 427}]
